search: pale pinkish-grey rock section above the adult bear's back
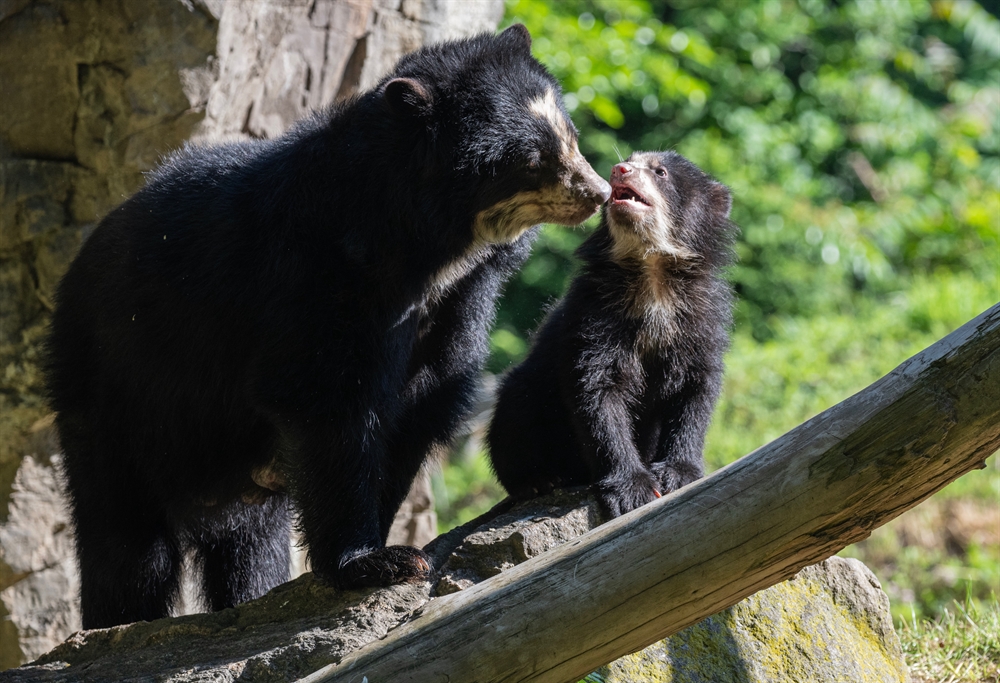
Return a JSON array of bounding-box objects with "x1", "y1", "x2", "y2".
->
[{"x1": 194, "y1": 0, "x2": 503, "y2": 138}]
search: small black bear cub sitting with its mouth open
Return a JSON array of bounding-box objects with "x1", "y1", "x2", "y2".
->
[{"x1": 489, "y1": 152, "x2": 735, "y2": 517}]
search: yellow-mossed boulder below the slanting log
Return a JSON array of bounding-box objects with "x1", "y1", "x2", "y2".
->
[{"x1": 592, "y1": 557, "x2": 910, "y2": 683}]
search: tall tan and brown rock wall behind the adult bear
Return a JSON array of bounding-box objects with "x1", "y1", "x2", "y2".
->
[{"x1": 0, "y1": 0, "x2": 503, "y2": 669}]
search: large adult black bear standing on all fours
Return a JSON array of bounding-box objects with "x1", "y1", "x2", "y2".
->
[{"x1": 48, "y1": 26, "x2": 610, "y2": 628}]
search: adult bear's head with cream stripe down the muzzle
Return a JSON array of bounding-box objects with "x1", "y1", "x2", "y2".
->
[{"x1": 380, "y1": 24, "x2": 611, "y2": 243}]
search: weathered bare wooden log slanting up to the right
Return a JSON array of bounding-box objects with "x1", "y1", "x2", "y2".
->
[{"x1": 300, "y1": 305, "x2": 1000, "y2": 683}]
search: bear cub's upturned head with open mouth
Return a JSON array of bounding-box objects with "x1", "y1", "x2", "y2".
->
[{"x1": 604, "y1": 152, "x2": 735, "y2": 266}]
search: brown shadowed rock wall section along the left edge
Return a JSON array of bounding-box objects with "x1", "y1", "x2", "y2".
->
[{"x1": 0, "y1": 0, "x2": 218, "y2": 668}]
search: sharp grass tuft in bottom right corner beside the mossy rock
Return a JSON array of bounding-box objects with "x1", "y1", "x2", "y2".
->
[{"x1": 897, "y1": 595, "x2": 1000, "y2": 683}]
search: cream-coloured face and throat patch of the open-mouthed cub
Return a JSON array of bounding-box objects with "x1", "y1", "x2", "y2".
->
[{"x1": 608, "y1": 154, "x2": 697, "y2": 262}]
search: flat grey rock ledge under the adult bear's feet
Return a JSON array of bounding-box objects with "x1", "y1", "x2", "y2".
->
[{"x1": 10, "y1": 574, "x2": 429, "y2": 683}]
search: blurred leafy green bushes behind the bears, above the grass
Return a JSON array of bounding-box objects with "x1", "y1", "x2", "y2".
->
[{"x1": 491, "y1": 0, "x2": 1000, "y2": 352}]
